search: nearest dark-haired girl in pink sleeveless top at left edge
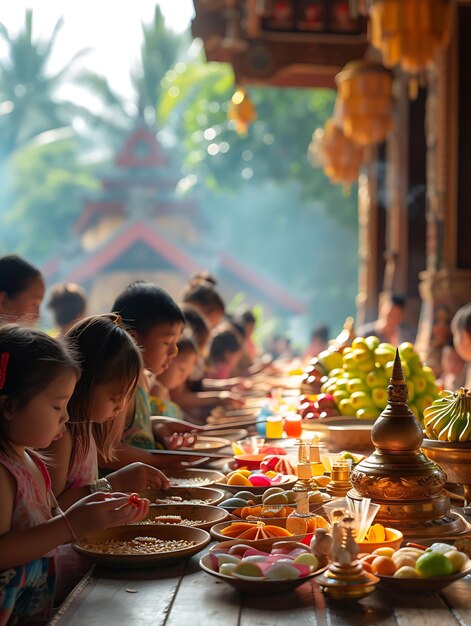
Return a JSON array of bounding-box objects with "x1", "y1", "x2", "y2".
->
[{"x1": 0, "y1": 326, "x2": 149, "y2": 626}]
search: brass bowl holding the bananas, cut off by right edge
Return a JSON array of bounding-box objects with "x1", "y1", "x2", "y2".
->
[{"x1": 422, "y1": 439, "x2": 471, "y2": 502}]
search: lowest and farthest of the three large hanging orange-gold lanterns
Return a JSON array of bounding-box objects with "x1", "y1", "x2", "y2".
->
[{"x1": 308, "y1": 119, "x2": 363, "y2": 186}]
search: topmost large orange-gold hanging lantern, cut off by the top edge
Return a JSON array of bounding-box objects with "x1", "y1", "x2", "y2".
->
[{"x1": 369, "y1": 0, "x2": 451, "y2": 76}]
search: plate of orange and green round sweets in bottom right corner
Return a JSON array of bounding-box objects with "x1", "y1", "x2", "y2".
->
[{"x1": 360, "y1": 539, "x2": 471, "y2": 594}]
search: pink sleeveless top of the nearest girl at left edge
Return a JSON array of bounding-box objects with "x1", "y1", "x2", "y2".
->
[{"x1": 0, "y1": 450, "x2": 57, "y2": 530}]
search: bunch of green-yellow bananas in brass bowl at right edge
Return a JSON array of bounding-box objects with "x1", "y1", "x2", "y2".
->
[{"x1": 424, "y1": 387, "x2": 471, "y2": 441}]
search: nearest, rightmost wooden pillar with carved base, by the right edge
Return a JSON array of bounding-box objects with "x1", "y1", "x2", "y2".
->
[{"x1": 417, "y1": 2, "x2": 471, "y2": 372}]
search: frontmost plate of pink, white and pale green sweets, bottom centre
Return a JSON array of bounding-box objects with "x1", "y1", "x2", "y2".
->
[{"x1": 200, "y1": 540, "x2": 325, "y2": 597}]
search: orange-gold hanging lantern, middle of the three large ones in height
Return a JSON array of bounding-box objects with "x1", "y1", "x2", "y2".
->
[{"x1": 335, "y1": 60, "x2": 393, "y2": 146}]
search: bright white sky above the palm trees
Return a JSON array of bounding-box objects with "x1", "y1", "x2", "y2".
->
[{"x1": 0, "y1": 0, "x2": 194, "y2": 95}]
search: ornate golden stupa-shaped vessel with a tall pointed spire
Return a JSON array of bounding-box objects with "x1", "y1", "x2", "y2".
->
[{"x1": 348, "y1": 351, "x2": 468, "y2": 537}]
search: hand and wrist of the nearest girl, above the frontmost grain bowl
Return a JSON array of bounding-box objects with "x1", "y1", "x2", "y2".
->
[{"x1": 64, "y1": 493, "x2": 150, "y2": 537}]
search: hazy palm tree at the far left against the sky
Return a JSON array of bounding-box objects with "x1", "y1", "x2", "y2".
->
[{"x1": 0, "y1": 10, "x2": 87, "y2": 157}]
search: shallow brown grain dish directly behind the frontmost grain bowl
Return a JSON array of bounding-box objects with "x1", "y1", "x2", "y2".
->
[{"x1": 129, "y1": 504, "x2": 230, "y2": 530}]
